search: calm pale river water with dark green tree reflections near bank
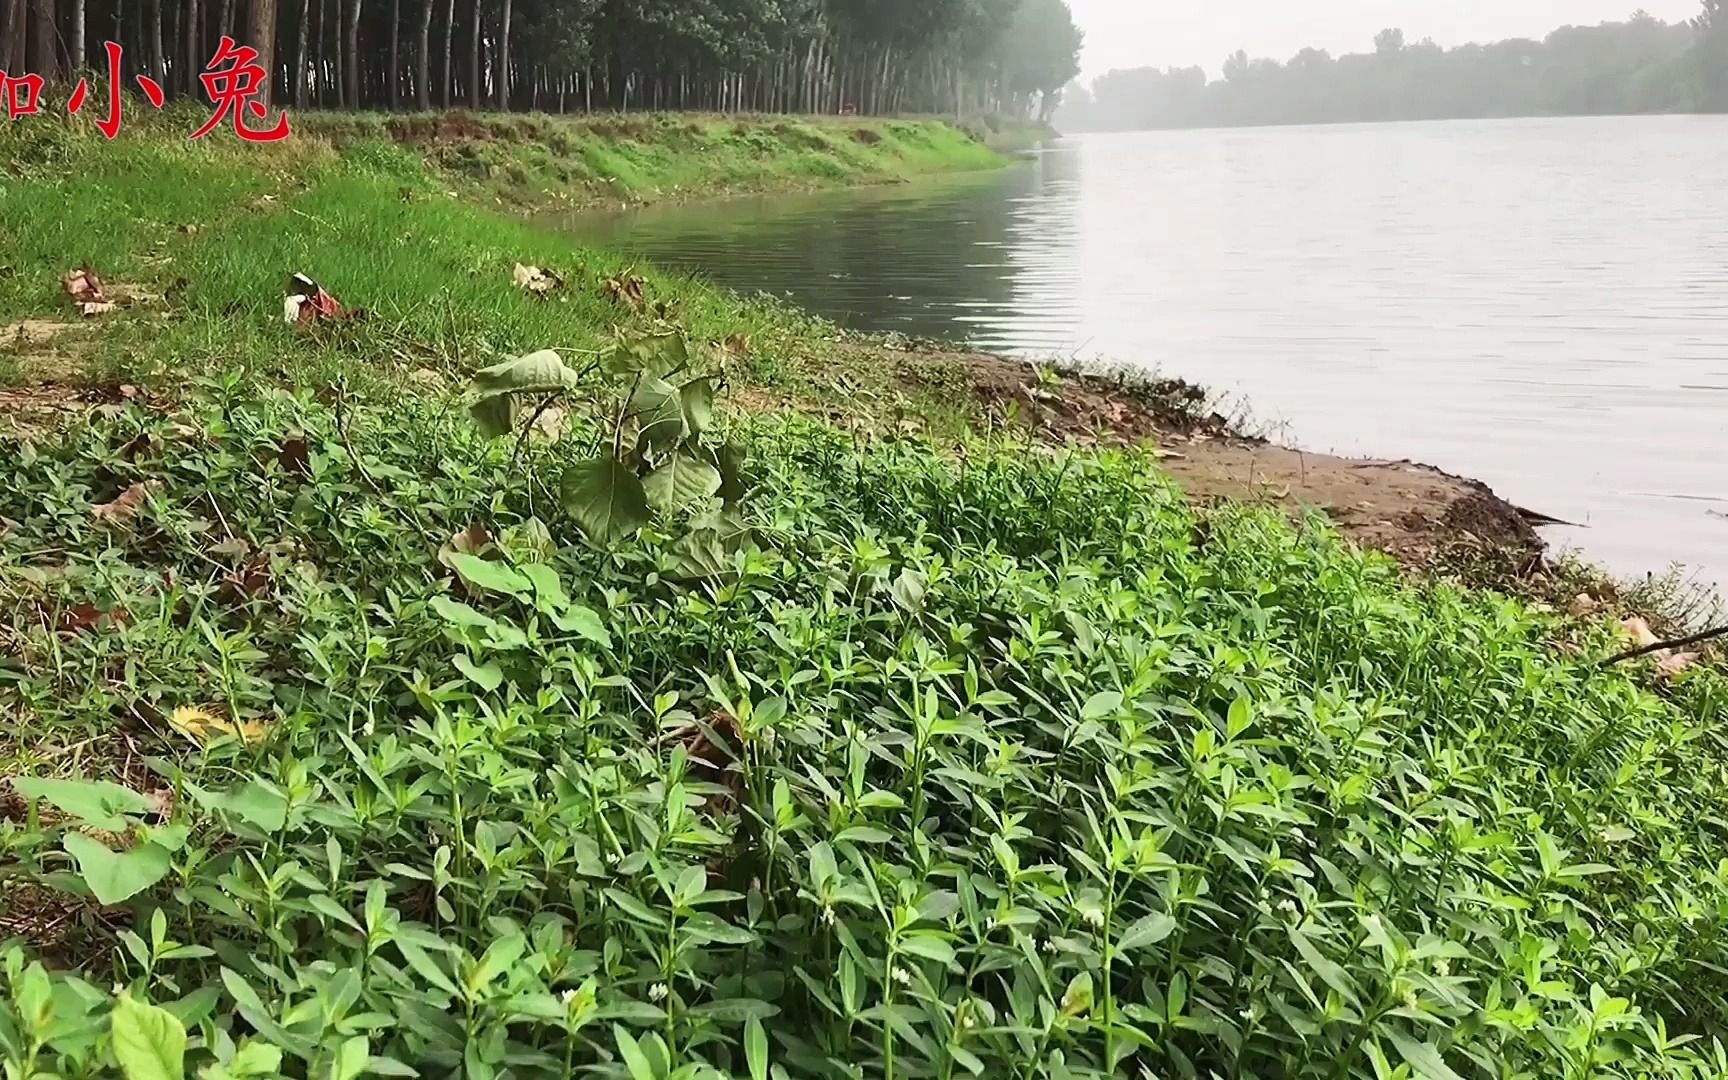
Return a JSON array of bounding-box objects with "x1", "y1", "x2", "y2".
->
[{"x1": 579, "y1": 116, "x2": 1728, "y2": 582}]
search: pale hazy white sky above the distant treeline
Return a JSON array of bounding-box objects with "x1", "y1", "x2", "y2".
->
[{"x1": 1068, "y1": 0, "x2": 1702, "y2": 79}]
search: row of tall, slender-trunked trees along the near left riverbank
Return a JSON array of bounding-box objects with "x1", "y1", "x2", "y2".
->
[{"x1": 0, "y1": 0, "x2": 1080, "y2": 114}]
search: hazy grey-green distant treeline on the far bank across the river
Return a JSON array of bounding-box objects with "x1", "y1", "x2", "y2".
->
[{"x1": 1058, "y1": 0, "x2": 1728, "y2": 131}]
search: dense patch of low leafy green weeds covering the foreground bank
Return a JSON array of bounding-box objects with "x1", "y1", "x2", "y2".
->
[{"x1": 0, "y1": 342, "x2": 1728, "y2": 1080}]
